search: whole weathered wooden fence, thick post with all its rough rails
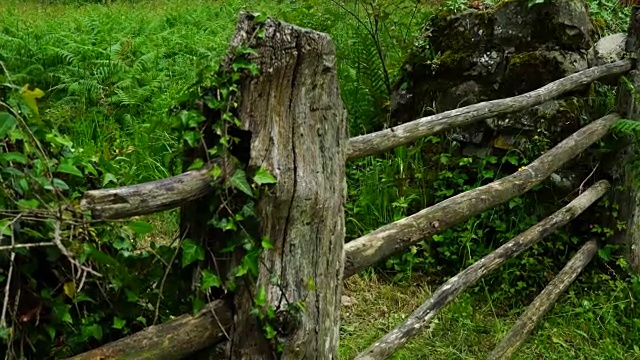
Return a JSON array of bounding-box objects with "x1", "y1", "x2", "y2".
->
[{"x1": 62, "y1": 6, "x2": 640, "y2": 360}]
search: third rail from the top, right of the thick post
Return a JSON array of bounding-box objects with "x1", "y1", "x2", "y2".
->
[{"x1": 356, "y1": 180, "x2": 610, "y2": 360}]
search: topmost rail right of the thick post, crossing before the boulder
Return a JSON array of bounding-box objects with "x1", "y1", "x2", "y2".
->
[{"x1": 347, "y1": 59, "x2": 632, "y2": 161}]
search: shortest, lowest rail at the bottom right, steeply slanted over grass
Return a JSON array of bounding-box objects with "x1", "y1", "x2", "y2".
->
[{"x1": 487, "y1": 240, "x2": 598, "y2": 360}]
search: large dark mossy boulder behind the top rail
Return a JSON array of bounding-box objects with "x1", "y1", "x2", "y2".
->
[{"x1": 391, "y1": 0, "x2": 594, "y2": 158}]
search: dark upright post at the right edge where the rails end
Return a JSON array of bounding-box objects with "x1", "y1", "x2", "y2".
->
[{"x1": 616, "y1": 5, "x2": 640, "y2": 271}]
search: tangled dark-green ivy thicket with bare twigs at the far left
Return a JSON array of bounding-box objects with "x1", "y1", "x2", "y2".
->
[{"x1": 0, "y1": 66, "x2": 198, "y2": 359}]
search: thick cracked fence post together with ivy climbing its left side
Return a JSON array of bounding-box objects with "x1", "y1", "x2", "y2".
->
[{"x1": 175, "y1": 13, "x2": 348, "y2": 359}]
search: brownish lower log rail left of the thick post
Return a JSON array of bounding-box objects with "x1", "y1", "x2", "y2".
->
[{"x1": 68, "y1": 300, "x2": 232, "y2": 360}]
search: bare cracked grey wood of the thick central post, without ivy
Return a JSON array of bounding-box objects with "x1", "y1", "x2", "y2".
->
[{"x1": 183, "y1": 13, "x2": 348, "y2": 359}]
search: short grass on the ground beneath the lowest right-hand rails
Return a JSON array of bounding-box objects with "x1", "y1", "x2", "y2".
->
[{"x1": 340, "y1": 276, "x2": 640, "y2": 360}]
